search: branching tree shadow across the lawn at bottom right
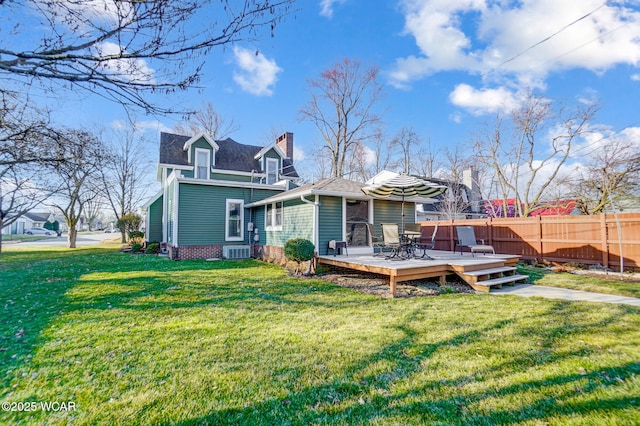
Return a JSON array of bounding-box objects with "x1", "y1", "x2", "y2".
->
[{"x1": 172, "y1": 306, "x2": 640, "y2": 425}]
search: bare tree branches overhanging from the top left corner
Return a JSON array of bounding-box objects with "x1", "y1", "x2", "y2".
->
[{"x1": 0, "y1": 0, "x2": 294, "y2": 112}]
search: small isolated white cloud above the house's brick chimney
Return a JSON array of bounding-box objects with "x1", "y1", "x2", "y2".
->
[{"x1": 233, "y1": 47, "x2": 282, "y2": 96}]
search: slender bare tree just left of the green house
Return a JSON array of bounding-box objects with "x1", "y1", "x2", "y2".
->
[{"x1": 100, "y1": 123, "x2": 150, "y2": 243}]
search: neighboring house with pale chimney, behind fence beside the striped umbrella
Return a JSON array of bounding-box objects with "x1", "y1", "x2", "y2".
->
[{"x1": 417, "y1": 168, "x2": 487, "y2": 222}]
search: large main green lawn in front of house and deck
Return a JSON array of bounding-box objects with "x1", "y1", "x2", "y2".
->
[{"x1": 0, "y1": 248, "x2": 640, "y2": 425}]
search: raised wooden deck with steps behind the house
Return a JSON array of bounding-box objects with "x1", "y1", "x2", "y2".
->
[{"x1": 318, "y1": 250, "x2": 528, "y2": 295}]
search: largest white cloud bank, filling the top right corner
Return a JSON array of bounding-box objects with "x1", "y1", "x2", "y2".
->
[{"x1": 390, "y1": 0, "x2": 640, "y2": 87}]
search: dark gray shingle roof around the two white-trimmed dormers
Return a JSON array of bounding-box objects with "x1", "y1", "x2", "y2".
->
[{"x1": 160, "y1": 132, "x2": 298, "y2": 178}]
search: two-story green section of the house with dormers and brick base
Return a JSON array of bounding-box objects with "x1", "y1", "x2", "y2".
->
[{"x1": 144, "y1": 133, "x2": 298, "y2": 260}]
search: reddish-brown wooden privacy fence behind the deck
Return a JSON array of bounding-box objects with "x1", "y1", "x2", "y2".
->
[{"x1": 421, "y1": 213, "x2": 640, "y2": 270}]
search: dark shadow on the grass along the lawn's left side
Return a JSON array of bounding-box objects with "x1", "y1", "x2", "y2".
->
[{"x1": 0, "y1": 247, "x2": 296, "y2": 396}]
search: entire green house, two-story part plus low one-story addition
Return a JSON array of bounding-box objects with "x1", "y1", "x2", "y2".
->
[{"x1": 144, "y1": 133, "x2": 436, "y2": 259}]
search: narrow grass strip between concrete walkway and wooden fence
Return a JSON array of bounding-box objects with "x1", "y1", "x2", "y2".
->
[{"x1": 518, "y1": 265, "x2": 640, "y2": 297}]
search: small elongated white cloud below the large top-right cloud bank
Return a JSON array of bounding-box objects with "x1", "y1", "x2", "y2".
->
[{"x1": 449, "y1": 84, "x2": 520, "y2": 115}]
